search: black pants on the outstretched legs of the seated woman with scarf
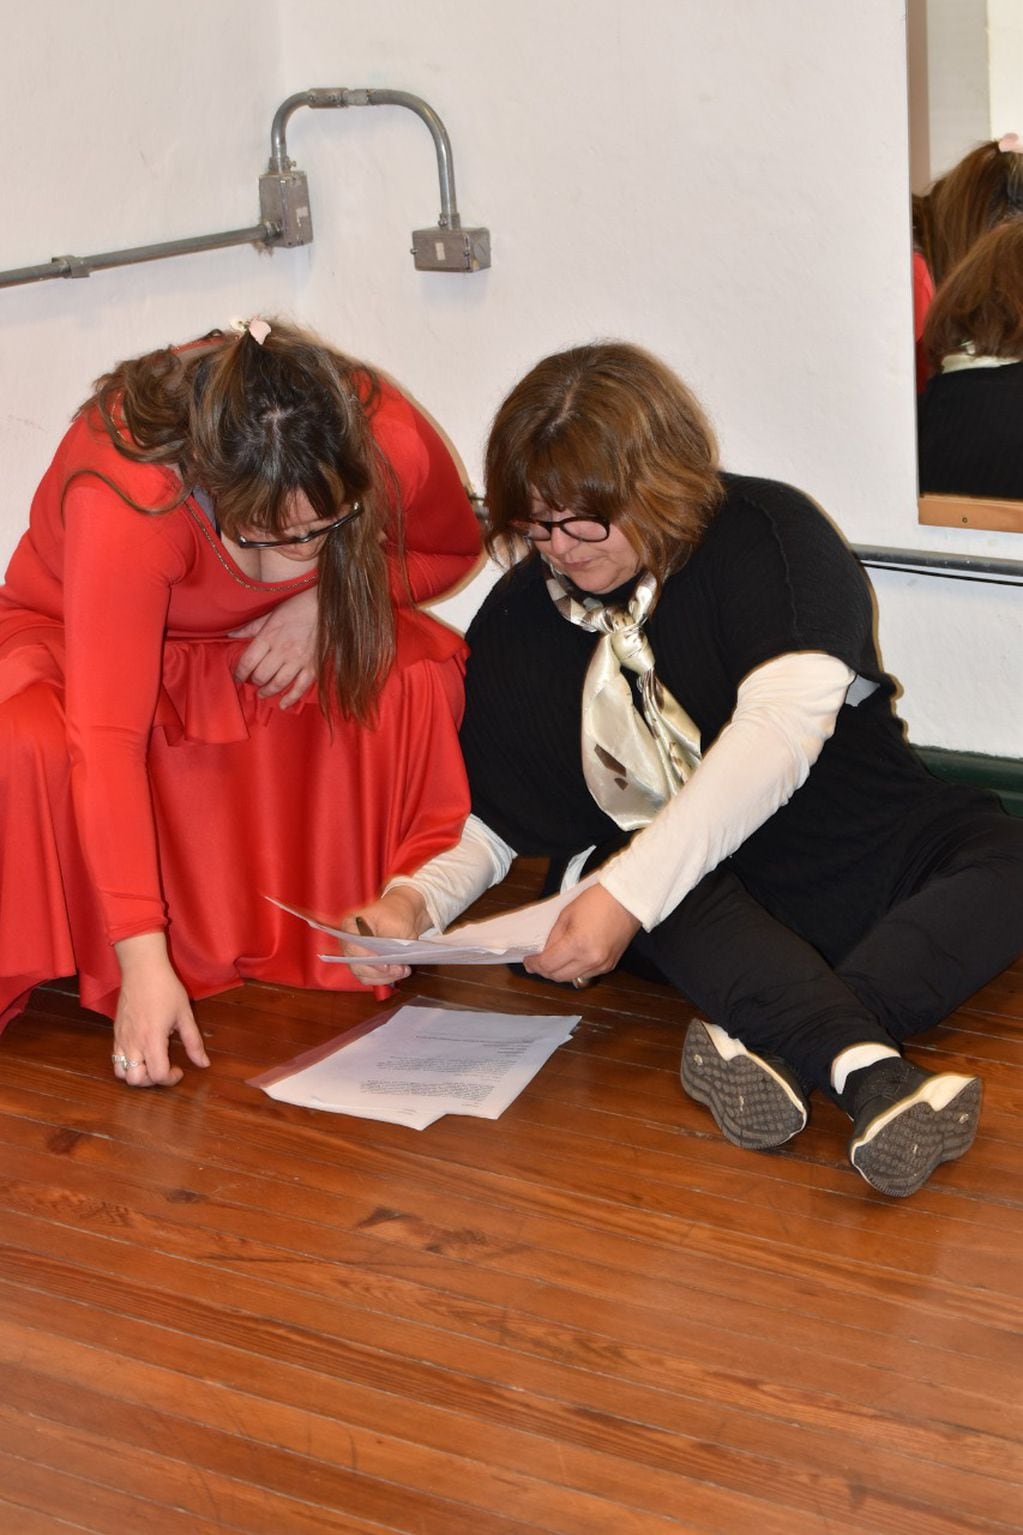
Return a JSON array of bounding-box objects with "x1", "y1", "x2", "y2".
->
[{"x1": 624, "y1": 803, "x2": 1023, "y2": 1090}]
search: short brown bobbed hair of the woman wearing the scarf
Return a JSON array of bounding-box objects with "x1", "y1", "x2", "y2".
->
[{"x1": 485, "y1": 341, "x2": 722, "y2": 582}]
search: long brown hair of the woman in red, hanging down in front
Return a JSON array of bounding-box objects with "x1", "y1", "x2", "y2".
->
[{"x1": 81, "y1": 319, "x2": 402, "y2": 721}]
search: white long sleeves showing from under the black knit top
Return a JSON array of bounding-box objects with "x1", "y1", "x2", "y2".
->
[{"x1": 387, "y1": 651, "x2": 856, "y2": 930}]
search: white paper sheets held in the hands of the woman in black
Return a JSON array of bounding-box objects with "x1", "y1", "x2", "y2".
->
[{"x1": 267, "y1": 873, "x2": 596, "y2": 964}]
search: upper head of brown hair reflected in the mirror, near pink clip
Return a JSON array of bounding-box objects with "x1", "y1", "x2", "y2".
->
[{"x1": 912, "y1": 138, "x2": 1023, "y2": 286}]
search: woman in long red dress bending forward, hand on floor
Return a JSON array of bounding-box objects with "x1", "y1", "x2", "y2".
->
[{"x1": 0, "y1": 321, "x2": 479, "y2": 1087}]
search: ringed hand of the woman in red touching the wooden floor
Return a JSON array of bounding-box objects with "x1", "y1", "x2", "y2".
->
[{"x1": 112, "y1": 933, "x2": 209, "y2": 1087}]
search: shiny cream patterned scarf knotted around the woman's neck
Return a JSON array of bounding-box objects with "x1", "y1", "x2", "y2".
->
[{"x1": 547, "y1": 566, "x2": 700, "y2": 832}]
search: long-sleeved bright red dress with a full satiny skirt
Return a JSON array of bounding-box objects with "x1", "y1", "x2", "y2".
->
[{"x1": 0, "y1": 373, "x2": 479, "y2": 1027}]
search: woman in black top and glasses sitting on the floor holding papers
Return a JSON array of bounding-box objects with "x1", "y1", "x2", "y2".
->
[{"x1": 342, "y1": 344, "x2": 1023, "y2": 1194}]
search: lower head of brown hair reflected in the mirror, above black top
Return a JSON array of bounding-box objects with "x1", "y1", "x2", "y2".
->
[{"x1": 923, "y1": 220, "x2": 1023, "y2": 367}]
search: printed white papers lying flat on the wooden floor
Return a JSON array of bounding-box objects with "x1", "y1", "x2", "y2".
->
[{"x1": 250, "y1": 998, "x2": 579, "y2": 1130}]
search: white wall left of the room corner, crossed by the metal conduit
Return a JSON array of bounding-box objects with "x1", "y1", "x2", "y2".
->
[{"x1": 0, "y1": 0, "x2": 296, "y2": 540}]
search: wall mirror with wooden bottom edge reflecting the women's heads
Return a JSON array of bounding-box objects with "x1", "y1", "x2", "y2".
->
[{"x1": 906, "y1": 0, "x2": 1023, "y2": 533}]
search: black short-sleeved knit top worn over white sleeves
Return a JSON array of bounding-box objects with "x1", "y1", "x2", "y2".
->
[{"x1": 462, "y1": 476, "x2": 945, "y2": 951}]
